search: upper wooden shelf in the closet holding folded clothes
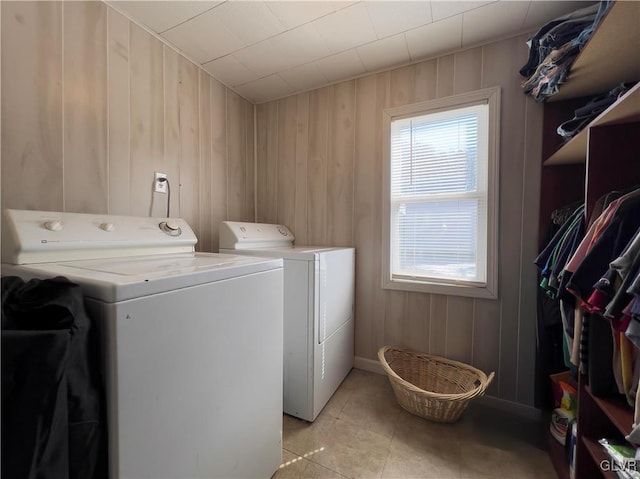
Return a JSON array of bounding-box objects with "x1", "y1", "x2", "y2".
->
[{"x1": 547, "y1": 0, "x2": 640, "y2": 102}]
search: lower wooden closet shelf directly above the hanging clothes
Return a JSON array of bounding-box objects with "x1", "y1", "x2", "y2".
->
[{"x1": 543, "y1": 85, "x2": 640, "y2": 166}]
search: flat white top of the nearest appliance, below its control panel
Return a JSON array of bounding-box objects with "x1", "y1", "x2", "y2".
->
[{"x1": 2, "y1": 253, "x2": 282, "y2": 303}]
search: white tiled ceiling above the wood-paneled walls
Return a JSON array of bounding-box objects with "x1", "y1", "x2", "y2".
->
[{"x1": 107, "y1": 0, "x2": 593, "y2": 103}]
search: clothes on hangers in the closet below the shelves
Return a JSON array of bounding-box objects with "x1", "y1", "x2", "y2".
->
[{"x1": 535, "y1": 187, "x2": 640, "y2": 412}]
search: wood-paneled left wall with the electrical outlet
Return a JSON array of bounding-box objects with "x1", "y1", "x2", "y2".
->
[{"x1": 0, "y1": 1, "x2": 255, "y2": 251}]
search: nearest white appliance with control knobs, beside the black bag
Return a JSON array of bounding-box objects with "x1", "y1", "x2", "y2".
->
[{"x1": 2, "y1": 210, "x2": 283, "y2": 479}]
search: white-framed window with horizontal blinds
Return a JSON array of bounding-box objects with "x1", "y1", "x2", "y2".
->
[{"x1": 383, "y1": 88, "x2": 499, "y2": 298}]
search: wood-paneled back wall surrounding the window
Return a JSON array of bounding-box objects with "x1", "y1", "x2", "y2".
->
[{"x1": 256, "y1": 36, "x2": 542, "y2": 405}]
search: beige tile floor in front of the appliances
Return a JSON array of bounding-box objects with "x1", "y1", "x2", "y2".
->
[{"x1": 273, "y1": 369, "x2": 555, "y2": 479}]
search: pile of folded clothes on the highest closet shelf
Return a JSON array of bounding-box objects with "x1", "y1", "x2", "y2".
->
[{"x1": 520, "y1": 0, "x2": 613, "y2": 102}]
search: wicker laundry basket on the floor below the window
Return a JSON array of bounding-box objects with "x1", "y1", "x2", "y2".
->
[{"x1": 378, "y1": 346, "x2": 494, "y2": 422}]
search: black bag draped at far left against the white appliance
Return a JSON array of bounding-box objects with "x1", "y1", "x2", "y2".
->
[{"x1": 1, "y1": 277, "x2": 107, "y2": 479}]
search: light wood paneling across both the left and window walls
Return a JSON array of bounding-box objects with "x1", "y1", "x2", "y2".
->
[{"x1": 0, "y1": 2, "x2": 542, "y2": 404}]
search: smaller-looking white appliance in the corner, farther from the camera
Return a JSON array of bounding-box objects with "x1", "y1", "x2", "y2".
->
[{"x1": 220, "y1": 221, "x2": 355, "y2": 421}]
